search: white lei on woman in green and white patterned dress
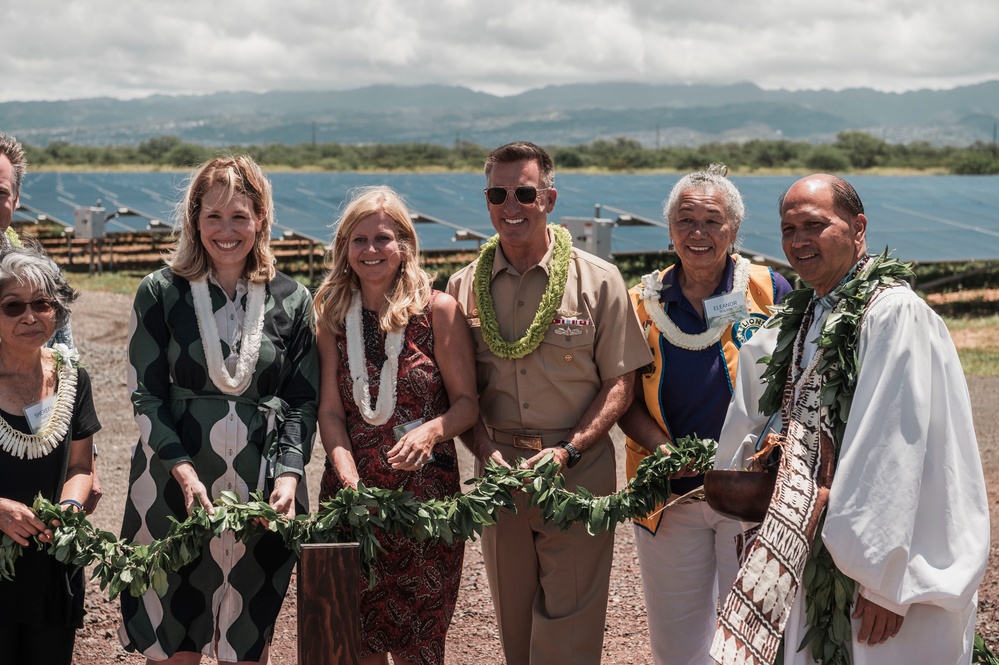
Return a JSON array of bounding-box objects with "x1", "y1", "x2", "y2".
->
[{"x1": 191, "y1": 277, "x2": 266, "y2": 395}]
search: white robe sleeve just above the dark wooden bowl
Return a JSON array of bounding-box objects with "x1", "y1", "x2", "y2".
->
[{"x1": 715, "y1": 328, "x2": 780, "y2": 471}]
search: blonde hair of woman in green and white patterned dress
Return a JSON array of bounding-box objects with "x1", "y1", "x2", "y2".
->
[{"x1": 166, "y1": 155, "x2": 276, "y2": 282}]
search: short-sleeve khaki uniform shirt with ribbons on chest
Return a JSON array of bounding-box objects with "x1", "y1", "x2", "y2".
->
[{"x1": 447, "y1": 234, "x2": 652, "y2": 434}]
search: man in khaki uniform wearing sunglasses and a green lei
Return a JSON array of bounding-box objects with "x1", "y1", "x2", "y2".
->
[{"x1": 447, "y1": 142, "x2": 650, "y2": 665}]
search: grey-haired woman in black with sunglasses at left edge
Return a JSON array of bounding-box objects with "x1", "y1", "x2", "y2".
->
[{"x1": 0, "y1": 246, "x2": 101, "y2": 665}]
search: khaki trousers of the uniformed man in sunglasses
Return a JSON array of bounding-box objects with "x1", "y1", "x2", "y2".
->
[{"x1": 482, "y1": 436, "x2": 616, "y2": 665}]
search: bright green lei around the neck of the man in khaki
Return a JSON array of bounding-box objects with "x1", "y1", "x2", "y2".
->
[{"x1": 472, "y1": 224, "x2": 572, "y2": 359}]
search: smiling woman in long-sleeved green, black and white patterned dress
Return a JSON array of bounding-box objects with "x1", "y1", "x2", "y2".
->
[{"x1": 119, "y1": 156, "x2": 319, "y2": 663}]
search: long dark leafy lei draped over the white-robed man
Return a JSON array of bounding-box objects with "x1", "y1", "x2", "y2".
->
[{"x1": 760, "y1": 249, "x2": 912, "y2": 664}]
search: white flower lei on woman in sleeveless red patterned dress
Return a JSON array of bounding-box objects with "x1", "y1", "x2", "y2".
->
[{"x1": 344, "y1": 291, "x2": 406, "y2": 425}]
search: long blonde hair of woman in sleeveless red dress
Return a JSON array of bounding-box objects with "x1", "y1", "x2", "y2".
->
[{"x1": 312, "y1": 186, "x2": 430, "y2": 334}]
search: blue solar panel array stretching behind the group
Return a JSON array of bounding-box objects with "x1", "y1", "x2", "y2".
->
[{"x1": 18, "y1": 172, "x2": 999, "y2": 262}]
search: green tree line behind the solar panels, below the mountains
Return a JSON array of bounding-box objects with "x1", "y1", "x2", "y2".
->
[{"x1": 19, "y1": 131, "x2": 999, "y2": 175}]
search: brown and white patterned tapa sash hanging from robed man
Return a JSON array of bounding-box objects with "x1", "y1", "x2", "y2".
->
[{"x1": 711, "y1": 352, "x2": 835, "y2": 665}]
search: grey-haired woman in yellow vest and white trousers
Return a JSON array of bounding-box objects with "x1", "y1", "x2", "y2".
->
[{"x1": 619, "y1": 164, "x2": 791, "y2": 665}]
